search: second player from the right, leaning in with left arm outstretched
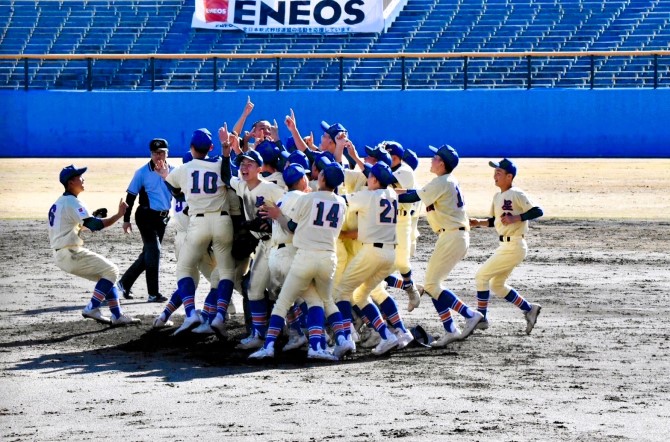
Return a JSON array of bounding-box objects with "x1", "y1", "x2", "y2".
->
[{"x1": 398, "y1": 145, "x2": 484, "y2": 347}]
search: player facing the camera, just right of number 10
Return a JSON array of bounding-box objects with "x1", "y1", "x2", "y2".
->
[{"x1": 230, "y1": 145, "x2": 285, "y2": 349}]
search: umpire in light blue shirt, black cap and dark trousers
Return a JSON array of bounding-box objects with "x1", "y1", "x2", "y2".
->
[{"x1": 119, "y1": 138, "x2": 174, "y2": 302}]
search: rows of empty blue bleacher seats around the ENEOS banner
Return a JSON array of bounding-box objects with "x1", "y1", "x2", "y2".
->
[{"x1": 0, "y1": 0, "x2": 670, "y2": 90}]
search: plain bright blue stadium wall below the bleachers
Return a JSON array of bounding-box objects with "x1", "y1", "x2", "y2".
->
[{"x1": 0, "y1": 89, "x2": 670, "y2": 158}]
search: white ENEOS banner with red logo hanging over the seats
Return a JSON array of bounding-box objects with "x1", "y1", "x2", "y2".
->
[{"x1": 192, "y1": 0, "x2": 384, "y2": 34}]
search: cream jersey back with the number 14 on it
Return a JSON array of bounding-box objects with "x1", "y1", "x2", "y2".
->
[{"x1": 287, "y1": 191, "x2": 346, "y2": 252}]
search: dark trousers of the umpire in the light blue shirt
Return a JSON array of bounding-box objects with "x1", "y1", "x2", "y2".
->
[{"x1": 120, "y1": 207, "x2": 168, "y2": 295}]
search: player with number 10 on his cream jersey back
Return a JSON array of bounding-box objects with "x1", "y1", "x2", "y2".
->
[{"x1": 158, "y1": 128, "x2": 235, "y2": 334}]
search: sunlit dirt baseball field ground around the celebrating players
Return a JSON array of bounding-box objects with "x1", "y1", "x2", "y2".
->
[{"x1": 0, "y1": 159, "x2": 670, "y2": 441}]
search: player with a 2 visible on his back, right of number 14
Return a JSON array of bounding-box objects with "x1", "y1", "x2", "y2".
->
[{"x1": 334, "y1": 162, "x2": 413, "y2": 355}]
